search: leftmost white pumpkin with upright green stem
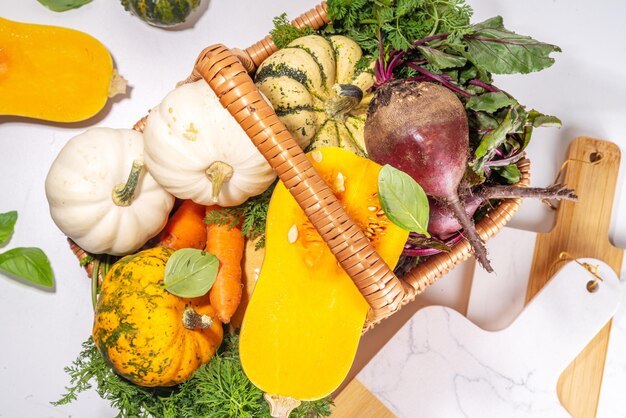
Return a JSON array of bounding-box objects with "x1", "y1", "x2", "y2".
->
[{"x1": 46, "y1": 128, "x2": 174, "y2": 255}]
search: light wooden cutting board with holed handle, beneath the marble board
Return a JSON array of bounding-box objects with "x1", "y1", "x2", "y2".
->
[{"x1": 526, "y1": 137, "x2": 624, "y2": 418}]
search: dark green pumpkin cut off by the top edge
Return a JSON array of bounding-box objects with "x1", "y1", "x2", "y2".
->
[{"x1": 122, "y1": 0, "x2": 200, "y2": 27}]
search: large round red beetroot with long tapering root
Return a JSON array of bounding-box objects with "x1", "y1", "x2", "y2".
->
[{"x1": 365, "y1": 80, "x2": 493, "y2": 272}]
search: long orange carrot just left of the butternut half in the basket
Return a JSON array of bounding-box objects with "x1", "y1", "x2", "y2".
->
[{"x1": 205, "y1": 206, "x2": 244, "y2": 324}]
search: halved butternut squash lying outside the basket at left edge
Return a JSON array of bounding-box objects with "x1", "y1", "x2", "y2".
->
[{"x1": 0, "y1": 18, "x2": 126, "y2": 122}]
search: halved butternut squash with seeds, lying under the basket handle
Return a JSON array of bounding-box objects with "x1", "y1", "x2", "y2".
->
[{"x1": 240, "y1": 148, "x2": 408, "y2": 400}]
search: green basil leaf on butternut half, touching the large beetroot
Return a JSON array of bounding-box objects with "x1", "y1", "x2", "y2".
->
[{"x1": 378, "y1": 164, "x2": 430, "y2": 237}]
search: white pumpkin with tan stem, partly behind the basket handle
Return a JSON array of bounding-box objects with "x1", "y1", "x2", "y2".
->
[{"x1": 144, "y1": 80, "x2": 276, "y2": 206}]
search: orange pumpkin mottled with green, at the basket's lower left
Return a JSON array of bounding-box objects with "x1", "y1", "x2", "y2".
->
[{"x1": 93, "y1": 247, "x2": 223, "y2": 387}]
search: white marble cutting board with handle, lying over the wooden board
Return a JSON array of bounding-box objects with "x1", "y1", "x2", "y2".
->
[{"x1": 359, "y1": 259, "x2": 621, "y2": 418}]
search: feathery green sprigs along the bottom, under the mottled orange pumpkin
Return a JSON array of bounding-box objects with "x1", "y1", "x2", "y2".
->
[{"x1": 52, "y1": 334, "x2": 332, "y2": 418}]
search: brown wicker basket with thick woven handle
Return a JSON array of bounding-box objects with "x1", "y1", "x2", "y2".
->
[{"x1": 75, "y1": 2, "x2": 530, "y2": 331}]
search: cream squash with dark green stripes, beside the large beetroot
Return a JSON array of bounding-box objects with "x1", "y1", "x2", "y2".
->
[{"x1": 255, "y1": 35, "x2": 374, "y2": 156}]
